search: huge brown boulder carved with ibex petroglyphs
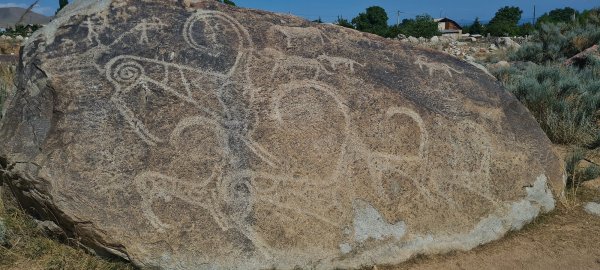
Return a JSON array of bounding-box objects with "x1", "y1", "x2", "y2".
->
[{"x1": 0, "y1": 0, "x2": 564, "y2": 269}]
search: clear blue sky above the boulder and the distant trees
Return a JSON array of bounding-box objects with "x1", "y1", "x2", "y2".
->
[{"x1": 0, "y1": 0, "x2": 600, "y2": 24}]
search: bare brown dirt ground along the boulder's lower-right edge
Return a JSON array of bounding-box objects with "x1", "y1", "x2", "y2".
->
[{"x1": 375, "y1": 188, "x2": 600, "y2": 270}]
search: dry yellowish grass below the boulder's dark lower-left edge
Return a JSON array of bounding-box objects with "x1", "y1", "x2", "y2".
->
[{"x1": 0, "y1": 187, "x2": 134, "y2": 270}]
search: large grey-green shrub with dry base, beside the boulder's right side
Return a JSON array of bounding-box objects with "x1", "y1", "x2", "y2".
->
[{"x1": 493, "y1": 59, "x2": 600, "y2": 146}]
